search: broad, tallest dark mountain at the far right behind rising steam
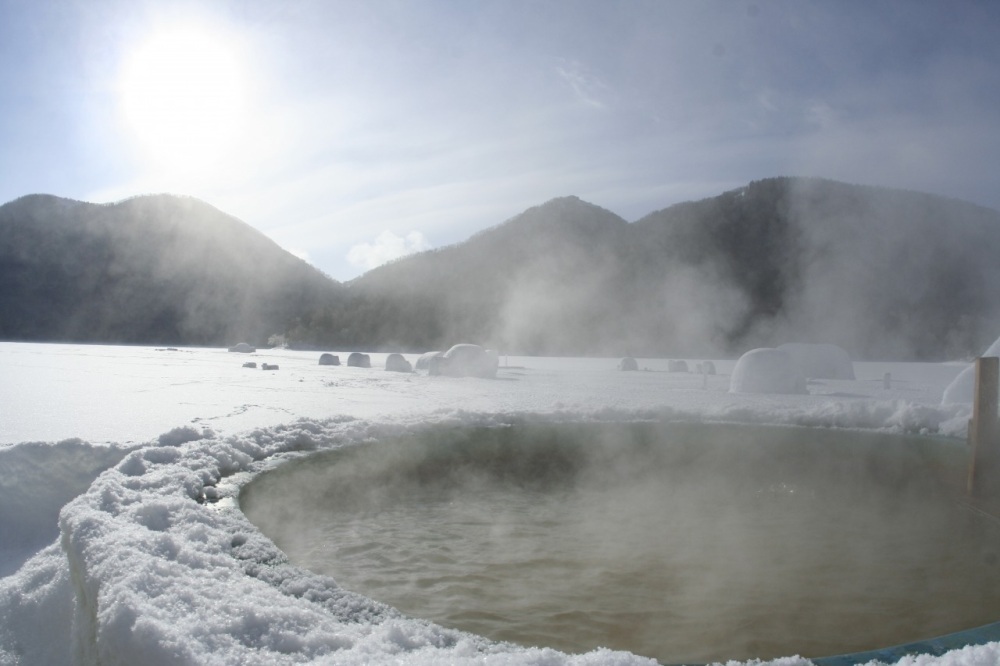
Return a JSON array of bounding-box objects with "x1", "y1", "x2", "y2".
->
[{"x1": 633, "y1": 178, "x2": 1000, "y2": 359}]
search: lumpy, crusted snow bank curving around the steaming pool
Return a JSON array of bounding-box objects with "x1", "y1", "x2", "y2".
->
[{"x1": 0, "y1": 396, "x2": 984, "y2": 665}]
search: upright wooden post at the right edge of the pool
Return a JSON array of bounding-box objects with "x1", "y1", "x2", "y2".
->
[{"x1": 968, "y1": 356, "x2": 1000, "y2": 499}]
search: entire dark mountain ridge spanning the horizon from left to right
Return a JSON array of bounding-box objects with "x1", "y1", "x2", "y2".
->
[{"x1": 0, "y1": 178, "x2": 1000, "y2": 360}]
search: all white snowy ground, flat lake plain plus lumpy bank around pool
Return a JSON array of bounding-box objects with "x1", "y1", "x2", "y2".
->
[{"x1": 0, "y1": 343, "x2": 984, "y2": 664}]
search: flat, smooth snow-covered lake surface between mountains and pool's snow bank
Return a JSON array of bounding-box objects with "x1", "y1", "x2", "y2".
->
[{"x1": 0, "y1": 342, "x2": 965, "y2": 445}]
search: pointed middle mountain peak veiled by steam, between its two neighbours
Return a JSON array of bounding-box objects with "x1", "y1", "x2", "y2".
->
[{"x1": 320, "y1": 197, "x2": 628, "y2": 354}]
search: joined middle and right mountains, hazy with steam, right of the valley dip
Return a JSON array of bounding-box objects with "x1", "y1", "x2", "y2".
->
[{"x1": 298, "y1": 178, "x2": 1000, "y2": 359}]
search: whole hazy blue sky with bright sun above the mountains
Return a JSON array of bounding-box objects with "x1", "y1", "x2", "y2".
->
[{"x1": 0, "y1": 0, "x2": 1000, "y2": 280}]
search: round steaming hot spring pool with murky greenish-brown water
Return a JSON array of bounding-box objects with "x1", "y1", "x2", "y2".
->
[{"x1": 240, "y1": 423, "x2": 1000, "y2": 663}]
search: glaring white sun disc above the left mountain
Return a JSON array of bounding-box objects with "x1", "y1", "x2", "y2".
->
[{"x1": 120, "y1": 26, "x2": 246, "y2": 171}]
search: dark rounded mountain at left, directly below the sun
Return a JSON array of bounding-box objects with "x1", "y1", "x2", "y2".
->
[{"x1": 0, "y1": 195, "x2": 343, "y2": 345}]
